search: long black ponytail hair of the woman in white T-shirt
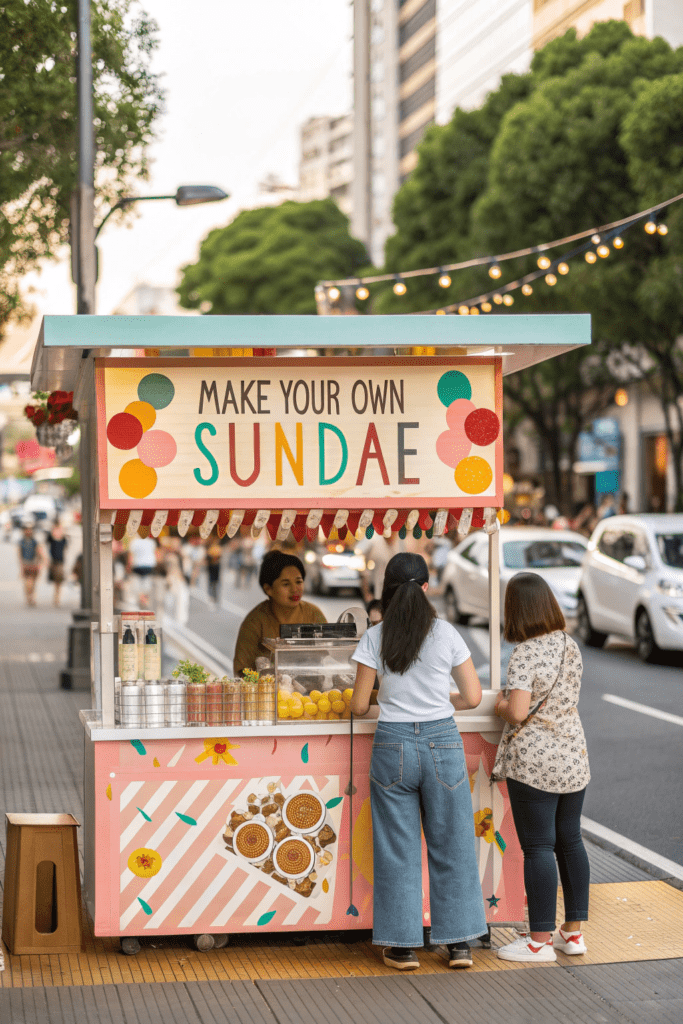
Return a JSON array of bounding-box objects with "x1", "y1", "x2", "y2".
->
[{"x1": 381, "y1": 552, "x2": 436, "y2": 675}]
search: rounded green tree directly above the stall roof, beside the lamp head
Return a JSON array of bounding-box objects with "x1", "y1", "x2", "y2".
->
[{"x1": 178, "y1": 199, "x2": 368, "y2": 313}]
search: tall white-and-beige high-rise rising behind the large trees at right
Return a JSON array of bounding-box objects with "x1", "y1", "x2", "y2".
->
[{"x1": 351, "y1": 0, "x2": 683, "y2": 266}]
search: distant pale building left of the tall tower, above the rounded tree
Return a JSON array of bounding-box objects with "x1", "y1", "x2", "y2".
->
[{"x1": 297, "y1": 114, "x2": 353, "y2": 216}]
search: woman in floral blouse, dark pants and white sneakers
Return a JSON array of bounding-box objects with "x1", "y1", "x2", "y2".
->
[{"x1": 494, "y1": 572, "x2": 591, "y2": 962}]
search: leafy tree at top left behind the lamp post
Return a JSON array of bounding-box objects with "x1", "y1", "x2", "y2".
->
[{"x1": 0, "y1": 0, "x2": 162, "y2": 334}]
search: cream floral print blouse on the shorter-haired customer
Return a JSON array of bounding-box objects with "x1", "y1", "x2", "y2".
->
[{"x1": 493, "y1": 630, "x2": 591, "y2": 793}]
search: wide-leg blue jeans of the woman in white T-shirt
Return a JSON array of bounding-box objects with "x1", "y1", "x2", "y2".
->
[{"x1": 370, "y1": 718, "x2": 486, "y2": 948}]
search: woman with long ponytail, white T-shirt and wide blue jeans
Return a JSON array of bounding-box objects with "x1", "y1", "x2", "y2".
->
[{"x1": 351, "y1": 553, "x2": 486, "y2": 971}]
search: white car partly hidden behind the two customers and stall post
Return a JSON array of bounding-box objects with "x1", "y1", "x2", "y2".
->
[{"x1": 441, "y1": 526, "x2": 588, "y2": 626}]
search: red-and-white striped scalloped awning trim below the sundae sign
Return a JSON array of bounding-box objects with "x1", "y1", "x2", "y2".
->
[{"x1": 99, "y1": 507, "x2": 501, "y2": 542}]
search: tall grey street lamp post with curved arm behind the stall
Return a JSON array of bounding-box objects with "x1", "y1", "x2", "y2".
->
[{"x1": 67, "y1": 0, "x2": 227, "y2": 689}]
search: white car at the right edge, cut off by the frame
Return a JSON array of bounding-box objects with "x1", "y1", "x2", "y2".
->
[{"x1": 577, "y1": 513, "x2": 683, "y2": 662}]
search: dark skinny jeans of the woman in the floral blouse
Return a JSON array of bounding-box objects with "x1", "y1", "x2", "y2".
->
[{"x1": 507, "y1": 778, "x2": 590, "y2": 932}]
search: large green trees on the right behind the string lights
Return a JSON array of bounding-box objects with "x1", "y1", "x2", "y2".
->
[{"x1": 375, "y1": 22, "x2": 683, "y2": 507}]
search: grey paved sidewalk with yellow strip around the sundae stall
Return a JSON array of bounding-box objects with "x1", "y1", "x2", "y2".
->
[{"x1": 0, "y1": 565, "x2": 683, "y2": 1024}]
